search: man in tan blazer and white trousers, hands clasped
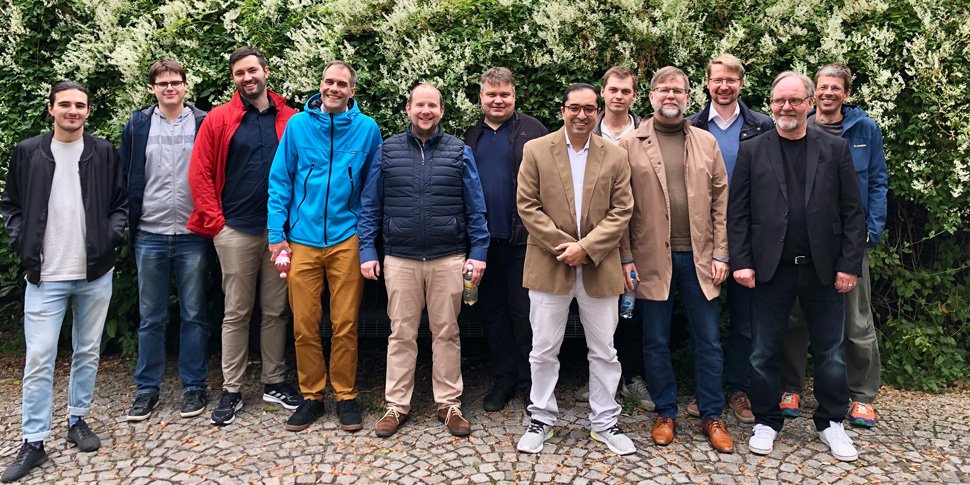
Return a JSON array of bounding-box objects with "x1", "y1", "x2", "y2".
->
[{"x1": 516, "y1": 84, "x2": 636, "y2": 455}]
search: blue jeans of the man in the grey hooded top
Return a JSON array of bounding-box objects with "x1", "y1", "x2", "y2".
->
[{"x1": 135, "y1": 231, "x2": 212, "y2": 394}]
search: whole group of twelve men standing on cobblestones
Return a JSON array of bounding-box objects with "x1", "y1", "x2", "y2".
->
[{"x1": 2, "y1": 42, "x2": 886, "y2": 481}]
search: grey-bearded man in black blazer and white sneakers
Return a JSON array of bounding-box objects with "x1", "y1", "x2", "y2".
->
[{"x1": 728, "y1": 71, "x2": 866, "y2": 461}]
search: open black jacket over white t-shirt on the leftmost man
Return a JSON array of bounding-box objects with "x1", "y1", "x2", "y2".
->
[{"x1": 0, "y1": 133, "x2": 128, "y2": 285}]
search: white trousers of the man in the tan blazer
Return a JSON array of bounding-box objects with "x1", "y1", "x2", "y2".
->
[{"x1": 529, "y1": 270, "x2": 620, "y2": 432}]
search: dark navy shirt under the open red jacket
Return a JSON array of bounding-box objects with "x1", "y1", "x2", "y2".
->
[{"x1": 222, "y1": 98, "x2": 279, "y2": 235}]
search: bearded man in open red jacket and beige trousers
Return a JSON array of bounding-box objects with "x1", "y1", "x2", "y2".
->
[{"x1": 187, "y1": 46, "x2": 303, "y2": 425}]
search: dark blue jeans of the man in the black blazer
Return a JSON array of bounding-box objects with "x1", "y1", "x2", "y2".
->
[{"x1": 748, "y1": 263, "x2": 849, "y2": 431}]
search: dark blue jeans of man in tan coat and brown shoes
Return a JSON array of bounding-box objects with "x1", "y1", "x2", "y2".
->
[{"x1": 637, "y1": 252, "x2": 724, "y2": 419}]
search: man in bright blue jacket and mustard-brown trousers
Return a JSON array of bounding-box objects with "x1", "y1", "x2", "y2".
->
[{"x1": 267, "y1": 60, "x2": 382, "y2": 431}]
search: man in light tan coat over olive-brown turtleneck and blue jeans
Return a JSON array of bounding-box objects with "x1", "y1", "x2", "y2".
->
[{"x1": 620, "y1": 67, "x2": 734, "y2": 453}]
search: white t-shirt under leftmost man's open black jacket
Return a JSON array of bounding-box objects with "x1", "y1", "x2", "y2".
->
[{"x1": 40, "y1": 138, "x2": 87, "y2": 281}]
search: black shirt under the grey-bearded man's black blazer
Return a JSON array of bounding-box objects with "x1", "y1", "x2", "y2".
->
[{"x1": 778, "y1": 136, "x2": 812, "y2": 264}]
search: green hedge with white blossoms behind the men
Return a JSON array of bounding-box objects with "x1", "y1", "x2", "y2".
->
[{"x1": 0, "y1": 0, "x2": 970, "y2": 390}]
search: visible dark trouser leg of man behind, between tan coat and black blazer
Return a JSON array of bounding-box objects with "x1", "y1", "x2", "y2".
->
[{"x1": 724, "y1": 276, "x2": 754, "y2": 396}]
